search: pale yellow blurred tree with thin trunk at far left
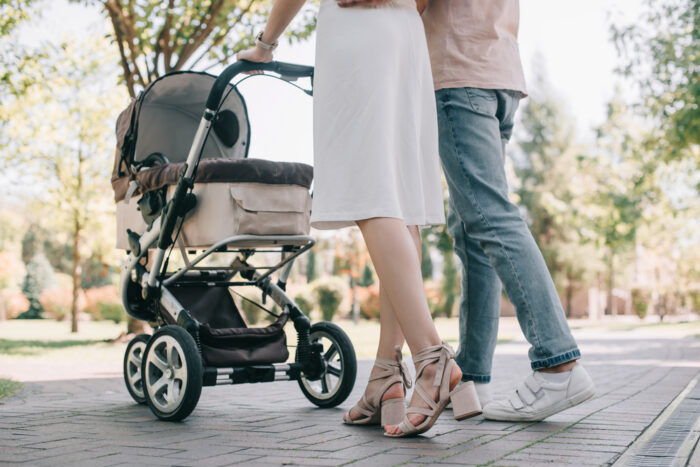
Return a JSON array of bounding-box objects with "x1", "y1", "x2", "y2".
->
[{"x1": 0, "y1": 38, "x2": 124, "y2": 332}]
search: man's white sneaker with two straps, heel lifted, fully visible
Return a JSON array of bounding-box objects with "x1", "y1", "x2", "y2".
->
[{"x1": 483, "y1": 364, "x2": 595, "y2": 422}]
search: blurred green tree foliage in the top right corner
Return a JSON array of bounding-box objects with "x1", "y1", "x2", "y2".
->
[{"x1": 611, "y1": 0, "x2": 700, "y2": 165}]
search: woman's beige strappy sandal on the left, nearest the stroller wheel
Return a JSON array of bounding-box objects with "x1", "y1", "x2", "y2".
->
[{"x1": 343, "y1": 347, "x2": 411, "y2": 426}]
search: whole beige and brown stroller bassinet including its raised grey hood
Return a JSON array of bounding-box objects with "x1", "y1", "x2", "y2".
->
[{"x1": 112, "y1": 72, "x2": 313, "y2": 249}]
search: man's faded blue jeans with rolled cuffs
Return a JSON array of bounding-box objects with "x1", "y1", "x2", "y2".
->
[{"x1": 435, "y1": 88, "x2": 581, "y2": 383}]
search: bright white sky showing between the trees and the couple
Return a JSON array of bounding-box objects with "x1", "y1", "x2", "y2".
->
[{"x1": 8, "y1": 0, "x2": 642, "y2": 174}]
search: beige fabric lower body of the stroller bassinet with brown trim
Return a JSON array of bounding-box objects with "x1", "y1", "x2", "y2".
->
[{"x1": 112, "y1": 159, "x2": 313, "y2": 249}]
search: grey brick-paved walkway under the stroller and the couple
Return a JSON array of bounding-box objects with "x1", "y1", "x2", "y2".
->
[{"x1": 0, "y1": 333, "x2": 700, "y2": 466}]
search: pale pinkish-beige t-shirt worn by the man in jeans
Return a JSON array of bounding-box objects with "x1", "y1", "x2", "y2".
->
[{"x1": 423, "y1": 0, "x2": 526, "y2": 94}]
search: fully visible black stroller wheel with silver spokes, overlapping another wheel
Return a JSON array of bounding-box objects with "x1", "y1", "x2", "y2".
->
[{"x1": 141, "y1": 326, "x2": 203, "y2": 421}]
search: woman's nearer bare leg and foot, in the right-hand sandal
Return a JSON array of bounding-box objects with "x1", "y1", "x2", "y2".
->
[{"x1": 357, "y1": 218, "x2": 462, "y2": 432}]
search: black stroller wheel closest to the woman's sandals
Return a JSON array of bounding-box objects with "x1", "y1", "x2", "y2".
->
[{"x1": 297, "y1": 321, "x2": 357, "y2": 408}]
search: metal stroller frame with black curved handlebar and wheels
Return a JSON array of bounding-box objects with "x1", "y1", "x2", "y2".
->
[{"x1": 120, "y1": 61, "x2": 357, "y2": 420}]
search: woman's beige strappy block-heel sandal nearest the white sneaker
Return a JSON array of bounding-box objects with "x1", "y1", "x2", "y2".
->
[{"x1": 384, "y1": 342, "x2": 481, "y2": 438}]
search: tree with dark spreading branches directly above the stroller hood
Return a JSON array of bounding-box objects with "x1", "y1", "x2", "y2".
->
[{"x1": 73, "y1": 0, "x2": 316, "y2": 97}]
